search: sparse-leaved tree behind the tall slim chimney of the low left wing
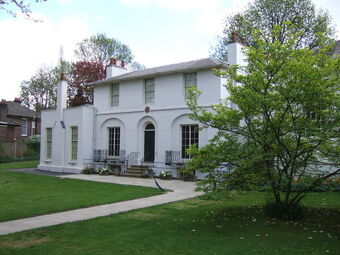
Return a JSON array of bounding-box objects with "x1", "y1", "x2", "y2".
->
[{"x1": 20, "y1": 61, "x2": 71, "y2": 111}]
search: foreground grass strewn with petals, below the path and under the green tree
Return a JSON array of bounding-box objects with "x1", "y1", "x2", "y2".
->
[{"x1": 0, "y1": 193, "x2": 340, "y2": 255}]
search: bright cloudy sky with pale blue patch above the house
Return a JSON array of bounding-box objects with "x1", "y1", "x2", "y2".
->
[{"x1": 0, "y1": 0, "x2": 340, "y2": 100}]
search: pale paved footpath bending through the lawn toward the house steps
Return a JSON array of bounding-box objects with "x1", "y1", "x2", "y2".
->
[{"x1": 0, "y1": 174, "x2": 201, "y2": 235}]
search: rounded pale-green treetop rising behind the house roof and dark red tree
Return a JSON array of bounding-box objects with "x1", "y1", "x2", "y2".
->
[{"x1": 75, "y1": 34, "x2": 144, "y2": 70}]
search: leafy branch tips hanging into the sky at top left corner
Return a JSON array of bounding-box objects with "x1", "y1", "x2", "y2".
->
[{"x1": 0, "y1": 0, "x2": 47, "y2": 18}]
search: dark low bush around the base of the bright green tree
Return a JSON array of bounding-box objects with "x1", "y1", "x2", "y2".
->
[{"x1": 264, "y1": 201, "x2": 307, "y2": 221}]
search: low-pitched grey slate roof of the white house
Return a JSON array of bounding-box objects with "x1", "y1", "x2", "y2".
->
[{"x1": 87, "y1": 58, "x2": 227, "y2": 85}]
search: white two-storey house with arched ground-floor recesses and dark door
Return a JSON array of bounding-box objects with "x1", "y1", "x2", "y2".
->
[{"x1": 38, "y1": 37, "x2": 244, "y2": 177}]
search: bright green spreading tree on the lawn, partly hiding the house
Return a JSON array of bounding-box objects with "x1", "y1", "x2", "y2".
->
[{"x1": 186, "y1": 27, "x2": 340, "y2": 218}]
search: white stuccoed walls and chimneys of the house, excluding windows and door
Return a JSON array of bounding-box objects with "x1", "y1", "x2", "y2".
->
[{"x1": 38, "y1": 40, "x2": 245, "y2": 174}]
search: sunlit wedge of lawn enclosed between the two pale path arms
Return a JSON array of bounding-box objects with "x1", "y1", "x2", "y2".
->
[{"x1": 0, "y1": 161, "x2": 162, "y2": 221}]
